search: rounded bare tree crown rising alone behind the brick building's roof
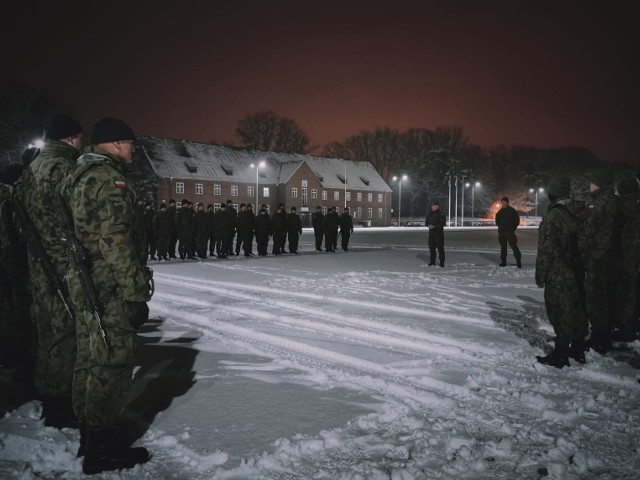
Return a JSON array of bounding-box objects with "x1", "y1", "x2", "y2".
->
[{"x1": 236, "y1": 110, "x2": 310, "y2": 153}]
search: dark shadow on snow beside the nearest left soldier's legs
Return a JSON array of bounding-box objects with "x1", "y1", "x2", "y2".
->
[{"x1": 124, "y1": 318, "x2": 199, "y2": 439}]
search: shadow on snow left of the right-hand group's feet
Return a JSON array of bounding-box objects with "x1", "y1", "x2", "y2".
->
[{"x1": 487, "y1": 295, "x2": 553, "y2": 350}]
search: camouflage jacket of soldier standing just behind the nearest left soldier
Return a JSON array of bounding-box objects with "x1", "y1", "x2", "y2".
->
[{"x1": 16, "y1": 140, "x2": 80, "y2": 262}]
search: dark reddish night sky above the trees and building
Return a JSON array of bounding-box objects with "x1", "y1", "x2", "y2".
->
[{"x1": 0, "y1": 0, "x2": 640, "y2": 164}]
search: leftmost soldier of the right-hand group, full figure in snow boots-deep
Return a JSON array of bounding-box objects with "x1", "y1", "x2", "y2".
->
[{"x1": 536, "y1": 176, "x2": 588, "y2": 368}]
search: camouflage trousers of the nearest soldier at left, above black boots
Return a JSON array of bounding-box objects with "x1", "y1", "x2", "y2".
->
[{"x1": 72, "y1": 290, "x2": 138, "y2": 427}]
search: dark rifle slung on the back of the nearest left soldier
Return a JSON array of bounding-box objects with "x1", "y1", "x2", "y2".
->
[{"x1": 55, "y1": 194, "x2": 111, "y2": 352}]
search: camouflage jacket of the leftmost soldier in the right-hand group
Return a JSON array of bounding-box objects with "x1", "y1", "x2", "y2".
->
[{"x1": 536, "y1": 199, "x2": 579, "y2": 287}]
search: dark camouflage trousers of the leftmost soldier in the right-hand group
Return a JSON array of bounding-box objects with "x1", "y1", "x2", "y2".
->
[{"x1": 544, "y1": 279, "x2": 589, "y2": 347}]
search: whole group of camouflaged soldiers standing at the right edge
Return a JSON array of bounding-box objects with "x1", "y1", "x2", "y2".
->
[{"x1": 535, "y1": 169, "x2": 640, "y2": 368}]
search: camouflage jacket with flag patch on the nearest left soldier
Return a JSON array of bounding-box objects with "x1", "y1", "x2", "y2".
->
[{"x1": 63, "y1": 149, "x2": 151, "y2": 302}]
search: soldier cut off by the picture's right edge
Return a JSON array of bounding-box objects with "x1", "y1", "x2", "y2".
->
[{"x1": 611, "y1": 177, "x2": 640, "y2": 342}]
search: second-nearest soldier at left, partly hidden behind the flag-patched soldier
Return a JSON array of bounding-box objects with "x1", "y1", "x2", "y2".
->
[{"x1": 16, "y1": 113, "x2": 82, "y2": 428}]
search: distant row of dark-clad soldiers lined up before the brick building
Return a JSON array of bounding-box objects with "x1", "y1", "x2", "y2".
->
[{"x1": 137, "y1": 198, "x2": 353, "y2": 260}]
